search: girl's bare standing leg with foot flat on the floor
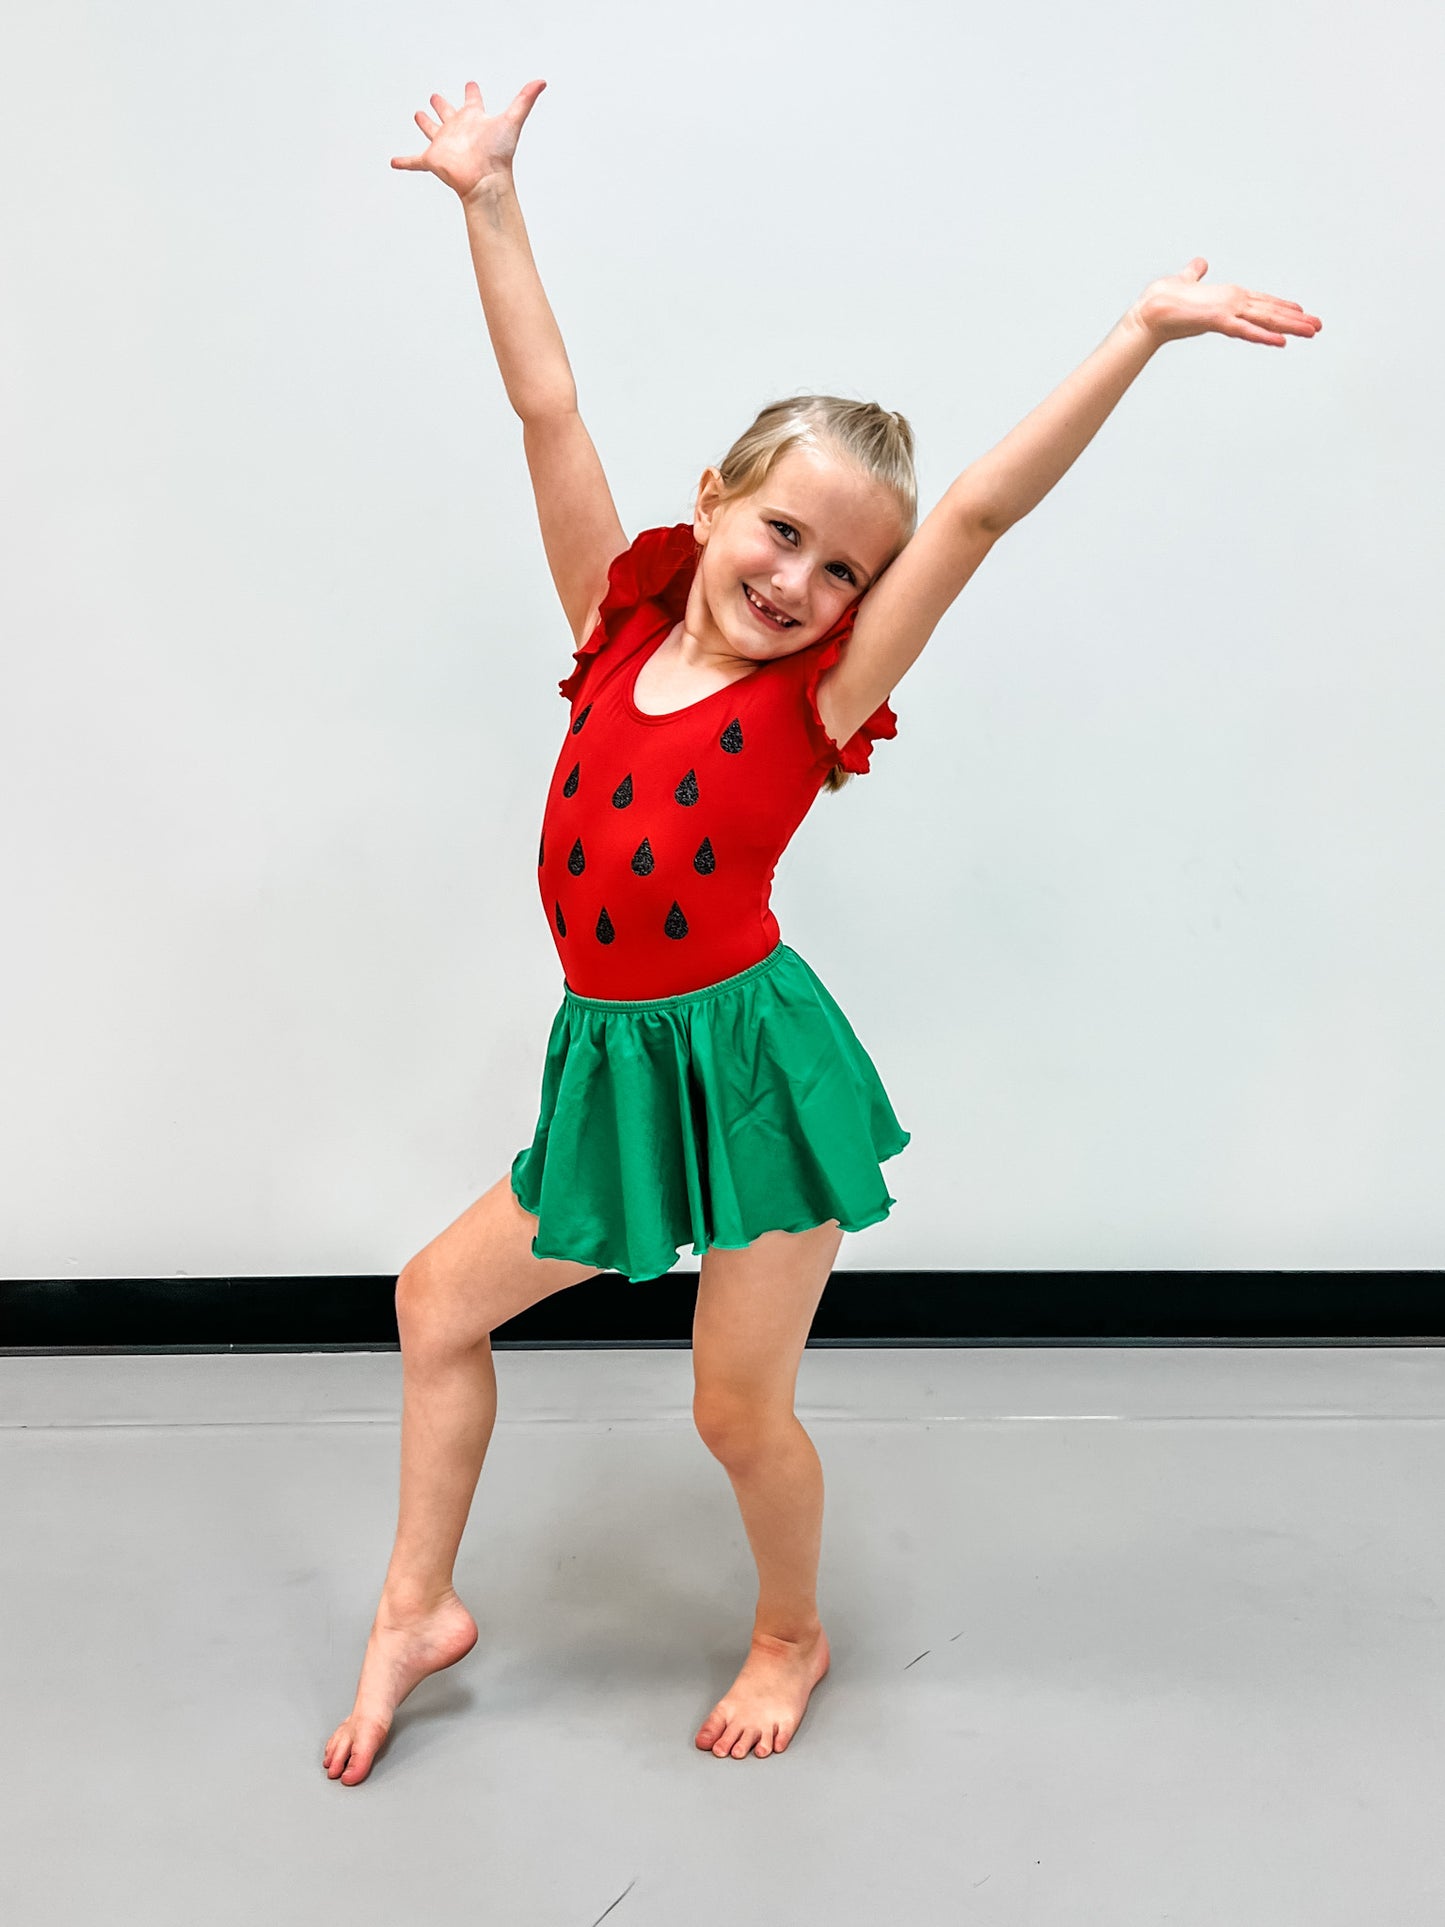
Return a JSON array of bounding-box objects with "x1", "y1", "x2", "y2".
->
[{"x1": 692, "y1": 1220, "x2": 842, "y2": 1759}]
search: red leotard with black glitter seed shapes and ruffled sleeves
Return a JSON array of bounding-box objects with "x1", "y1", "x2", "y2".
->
[{"x1": 538, "y1": 522, "x2": 898, "y2": 1000}]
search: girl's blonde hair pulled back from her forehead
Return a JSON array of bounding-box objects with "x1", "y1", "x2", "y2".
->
[{"x1": 697, "y1": 395, "x2": 919, "y2": 790}]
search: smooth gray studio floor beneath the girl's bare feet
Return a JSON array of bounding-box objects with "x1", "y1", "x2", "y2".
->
[{"x1": 0, "y1": 1347, "x2": 1445, "y2": 1927}]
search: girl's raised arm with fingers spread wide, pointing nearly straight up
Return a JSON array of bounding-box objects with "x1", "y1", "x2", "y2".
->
[{"x1": 391, "y1": 81, "x2": 628, "y2": 644}]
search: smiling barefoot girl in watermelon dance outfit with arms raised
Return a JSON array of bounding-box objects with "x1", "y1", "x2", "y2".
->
[{"x1": 324, "y1": 81, "x2": 1320, "y2": 1786}]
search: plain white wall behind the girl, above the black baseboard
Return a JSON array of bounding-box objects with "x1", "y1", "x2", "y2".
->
[{"x1": 0, "y1": 0, "x2": 1445, "y2": 1278}]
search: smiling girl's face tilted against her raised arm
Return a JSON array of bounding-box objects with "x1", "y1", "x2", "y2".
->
[{"x1": 686, "y1": 447, "x2": 902, "y2": 661}]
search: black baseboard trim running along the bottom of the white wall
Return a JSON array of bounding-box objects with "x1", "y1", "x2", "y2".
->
[{"x1": 0, "y1": 1270, "x2": 1445, "y2": 1357}]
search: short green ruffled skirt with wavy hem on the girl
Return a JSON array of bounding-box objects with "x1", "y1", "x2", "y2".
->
[{"x1": 511, "y1": 944, "x2": 909, "y2": 1283}]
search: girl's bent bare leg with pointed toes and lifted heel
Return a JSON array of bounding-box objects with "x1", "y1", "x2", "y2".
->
[{"x1": 322, "y1": 1175, "x2": 597, "y2": 1786}]
